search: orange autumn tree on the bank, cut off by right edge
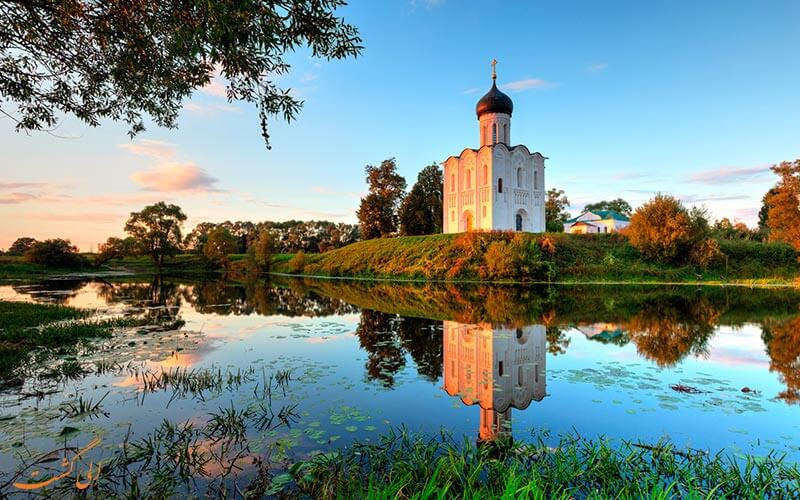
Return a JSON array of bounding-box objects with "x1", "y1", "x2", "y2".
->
[{"x1": 764, "y1": 159, "x2": 800, "y2": 250}]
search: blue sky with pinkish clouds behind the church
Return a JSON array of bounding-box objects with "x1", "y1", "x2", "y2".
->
[{"x1": 0, "y1": 0, "x2": 800, "y2": 249}]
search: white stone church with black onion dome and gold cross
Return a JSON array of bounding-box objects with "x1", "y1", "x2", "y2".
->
[{"x1": 442, "y1": 63, "x2": 547, "y2": 233}]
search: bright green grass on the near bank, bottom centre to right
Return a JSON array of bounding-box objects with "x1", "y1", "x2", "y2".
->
[{"x1": 280, "y1": 431, "x2": 800, "y2": 499}]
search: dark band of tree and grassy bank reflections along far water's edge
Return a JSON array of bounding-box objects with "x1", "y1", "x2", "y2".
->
[{"x1": 9, "y1": 277, "x2": 800, "y2": 410}]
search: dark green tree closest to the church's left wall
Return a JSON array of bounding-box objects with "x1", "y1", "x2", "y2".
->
[{"x1": 399, "y1": 163, "x2": 444, "y2": 235}]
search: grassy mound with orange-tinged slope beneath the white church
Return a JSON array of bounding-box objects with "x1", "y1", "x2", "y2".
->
[{"x1": 273, "y1": 233, "x2": 800, "y2": 284}]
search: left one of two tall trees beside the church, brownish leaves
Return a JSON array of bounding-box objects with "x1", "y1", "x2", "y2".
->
[{"x1": 356, "y1": 158, "x2": 406, "y2": 240}]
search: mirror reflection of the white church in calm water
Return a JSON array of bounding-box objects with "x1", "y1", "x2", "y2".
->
[{"x1": 443, "y1": 321, "x2": 547, "y2": 442}]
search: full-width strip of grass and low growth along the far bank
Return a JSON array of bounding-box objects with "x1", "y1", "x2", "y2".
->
[{"x1": 0, "y1": 232, "x2": 800, "y2": 287}]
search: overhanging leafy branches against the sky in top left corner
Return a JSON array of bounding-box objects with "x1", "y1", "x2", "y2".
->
[{"x1": 0, "y1": 0, "x2": 362, "y2": 147}]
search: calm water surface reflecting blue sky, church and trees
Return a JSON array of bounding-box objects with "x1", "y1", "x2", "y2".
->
[{"x1": 0, "y1": 280, "x2": 800, "y2": 488}]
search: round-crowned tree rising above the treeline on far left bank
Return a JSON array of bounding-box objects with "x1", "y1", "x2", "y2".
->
[{"x1": 125, "y1": 201, "x2": 186, "y2": 269}]
